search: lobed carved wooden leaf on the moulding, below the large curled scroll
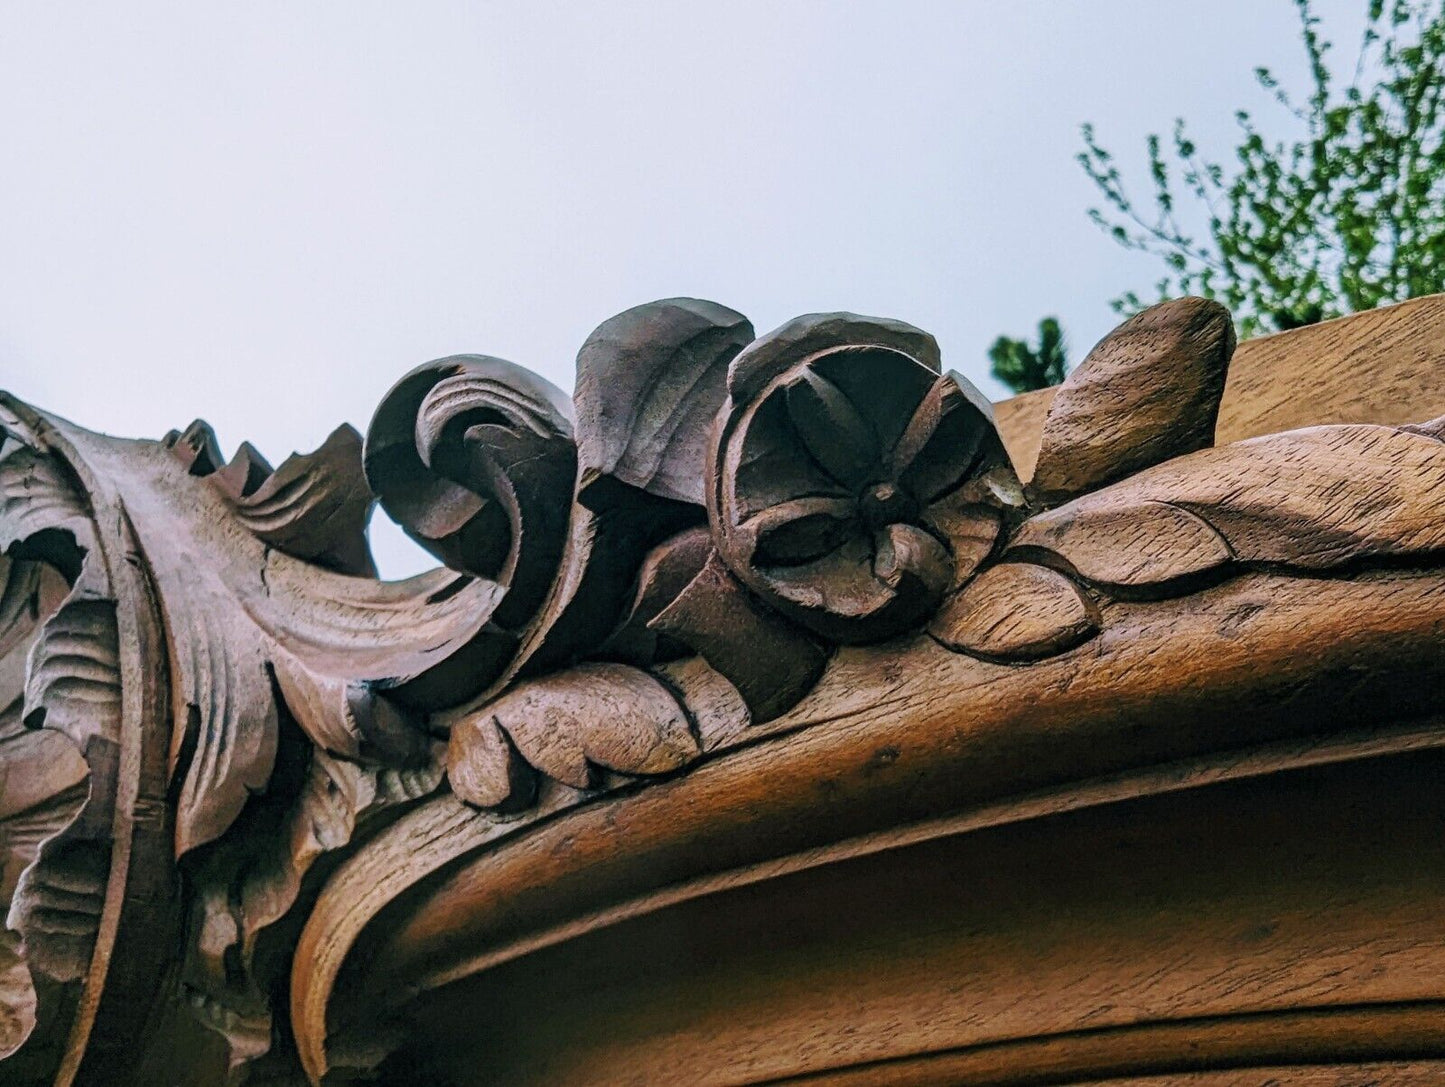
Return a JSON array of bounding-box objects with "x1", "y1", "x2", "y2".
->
[{"x1": 447, "y1": 663, "x2": 698, "y2": 805}]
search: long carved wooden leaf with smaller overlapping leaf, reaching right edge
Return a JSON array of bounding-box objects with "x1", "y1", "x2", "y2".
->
[{"x1": 1012, "y1": 425, "x2": 1445, "y2": 587}]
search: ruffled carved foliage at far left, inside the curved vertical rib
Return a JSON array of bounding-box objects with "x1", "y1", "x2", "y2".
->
[{"x1": 0, "y1": 422, "x2": 121, "y2": 1062}]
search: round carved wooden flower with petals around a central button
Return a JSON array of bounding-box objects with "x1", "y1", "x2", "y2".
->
[{"x1": 709, "y1": 314, "x2": 1022, "y2": 643}]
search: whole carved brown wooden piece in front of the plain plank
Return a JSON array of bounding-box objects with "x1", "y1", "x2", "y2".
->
[{"x1": 0, "y1": 299, "x2": 1445, "y2": 1087}]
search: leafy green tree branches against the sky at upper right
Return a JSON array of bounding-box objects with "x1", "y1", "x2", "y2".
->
[{"x1": 1078, "y1": 0, "x2": 1445, "y2": 335}]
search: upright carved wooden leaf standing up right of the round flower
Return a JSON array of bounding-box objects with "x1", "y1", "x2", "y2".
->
[{"x1": 1029, "y1": 298, "x2": 1234, "y2": 502}]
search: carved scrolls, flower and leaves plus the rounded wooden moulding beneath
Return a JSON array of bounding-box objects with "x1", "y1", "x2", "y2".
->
[{"x1": 0, "y1": 299, "x2": 1445, "y2": 1084}]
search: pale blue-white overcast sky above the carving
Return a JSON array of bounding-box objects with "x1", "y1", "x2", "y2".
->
[{"x1": 0, "y1": 0, "x2": 1364, "y2": 575}]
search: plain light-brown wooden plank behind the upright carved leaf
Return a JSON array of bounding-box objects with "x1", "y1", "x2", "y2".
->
[{"x1": 994, "y1": 295, "x2": 1445, "y2": 480}]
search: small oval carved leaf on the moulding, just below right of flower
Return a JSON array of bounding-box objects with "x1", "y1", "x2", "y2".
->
[{"x1": 928, "y1": 562, "x2": 1098, "y2": 661}]
